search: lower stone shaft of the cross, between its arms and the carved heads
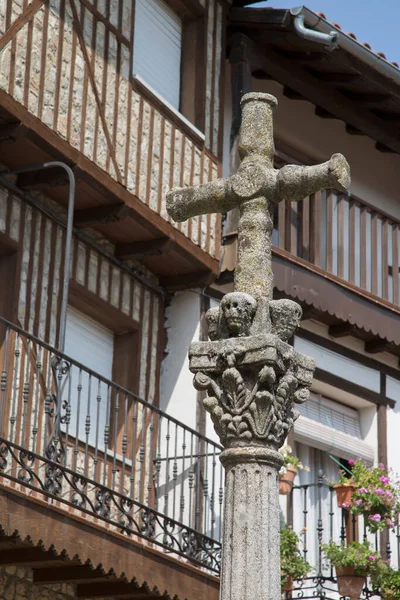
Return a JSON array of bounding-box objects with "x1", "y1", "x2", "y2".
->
[{"x1": 234, "y1": 196, "x2": 274, "y2": 300}]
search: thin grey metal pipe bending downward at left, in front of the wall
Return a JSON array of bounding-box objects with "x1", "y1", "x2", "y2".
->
[{"x1": 0, "y1": 160, "x2": 75, "y2": 352}]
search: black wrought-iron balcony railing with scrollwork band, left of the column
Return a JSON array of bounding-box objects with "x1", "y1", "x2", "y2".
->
[{"x1": 0, "y1": 319, "x2": 223, "y2": 572}]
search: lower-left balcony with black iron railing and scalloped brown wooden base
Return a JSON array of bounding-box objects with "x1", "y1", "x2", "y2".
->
[{"x1": 0, "y1": 320, "x2": 223, "y2": 600}]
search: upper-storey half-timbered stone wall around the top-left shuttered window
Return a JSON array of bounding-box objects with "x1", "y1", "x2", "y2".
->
[{"x1": 0, "y1": 0, "x2": 225, "y2": 256}]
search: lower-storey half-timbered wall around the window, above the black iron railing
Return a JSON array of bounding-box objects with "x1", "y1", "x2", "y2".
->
[{"x1": 0, "y1": 188, "x2": 163, "y2": 402}]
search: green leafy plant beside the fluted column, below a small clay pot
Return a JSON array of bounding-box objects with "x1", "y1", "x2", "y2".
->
[{"x1": 281, "y1": 527, "x2": 311, "y2": 592}]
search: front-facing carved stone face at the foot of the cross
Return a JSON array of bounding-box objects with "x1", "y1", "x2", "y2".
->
[{"x1": 221, "y1": 292, "x2": 257, "y2": 337}]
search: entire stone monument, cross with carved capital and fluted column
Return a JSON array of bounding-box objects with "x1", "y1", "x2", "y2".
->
[{"x1": 167, "y1": 93, "x2": 350, "y2": 600}]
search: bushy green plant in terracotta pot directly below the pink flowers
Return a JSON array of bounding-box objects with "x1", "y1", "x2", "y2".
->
[{"x1": 322, "y1": 540, "x2": 382, "y2": 600}]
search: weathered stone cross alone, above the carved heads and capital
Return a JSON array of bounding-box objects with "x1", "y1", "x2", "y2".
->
[{"x1": 167, "y1": 93, "x2": 350, "y2": 299}]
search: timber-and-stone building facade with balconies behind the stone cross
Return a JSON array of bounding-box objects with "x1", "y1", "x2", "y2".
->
[{"x1": 0, "y1": 0, "x2": 400, "y2": 600}]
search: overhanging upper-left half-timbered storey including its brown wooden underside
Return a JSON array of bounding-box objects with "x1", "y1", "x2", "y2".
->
[{"x1": 0, "y1": 0, "x2": 223, "y2": 287}]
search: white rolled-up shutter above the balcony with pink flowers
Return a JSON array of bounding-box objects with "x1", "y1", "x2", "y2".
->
[{"x1": 294, "y1": 394, "x2": 374, "y2": 463}]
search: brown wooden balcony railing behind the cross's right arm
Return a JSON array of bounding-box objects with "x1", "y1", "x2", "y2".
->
[{"x1": 274, "y1": 191, "x2": 400, "y2": 304}]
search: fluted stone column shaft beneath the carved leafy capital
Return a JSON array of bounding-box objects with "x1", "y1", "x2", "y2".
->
[{"x1": 220, "y1": 447, "x2": 282, "y2": 600}]
